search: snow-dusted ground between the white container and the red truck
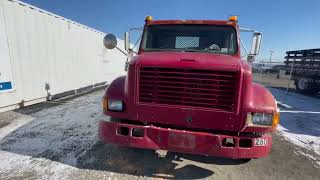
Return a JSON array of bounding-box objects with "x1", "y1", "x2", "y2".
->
[{"x1": 0, "y1": 91, "x2": 102, "y2": 179}]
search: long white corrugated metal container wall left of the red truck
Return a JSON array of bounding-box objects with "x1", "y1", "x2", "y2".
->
[{"x1": 0, "y1": 0, "x2": 126, "y2": 111}]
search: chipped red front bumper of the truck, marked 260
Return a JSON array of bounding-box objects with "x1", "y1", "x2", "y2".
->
[{"x1": 99, "y1": 121, "x2": 272, "y2": 159}]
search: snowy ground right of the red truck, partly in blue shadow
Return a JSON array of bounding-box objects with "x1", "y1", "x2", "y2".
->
[{"x1": 269, "y1": 88, "x2": 320, "y2": 165}]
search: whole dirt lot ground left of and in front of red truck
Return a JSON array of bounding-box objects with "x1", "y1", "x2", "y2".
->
[{"x1": 0, "y1": 91, "x2": 320, "y2": 180}]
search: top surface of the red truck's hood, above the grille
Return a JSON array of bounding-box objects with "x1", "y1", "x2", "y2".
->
[{"x1": 133, "y1": 51, "x2": 242, "y2": 71}]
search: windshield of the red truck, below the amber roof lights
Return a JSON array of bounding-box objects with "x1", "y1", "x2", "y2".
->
[{"x1": 142, "y1": 24, "x2": 237, "y2": 54}]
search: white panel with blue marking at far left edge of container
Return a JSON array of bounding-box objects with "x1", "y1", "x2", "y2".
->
[{"x1": 0, "y1": 6, "x2": 13, "y2": 93}]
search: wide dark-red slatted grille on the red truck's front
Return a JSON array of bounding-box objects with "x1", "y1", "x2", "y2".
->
[{"x1": 139, "y1": 67, "x2": 239, "y2": 112}]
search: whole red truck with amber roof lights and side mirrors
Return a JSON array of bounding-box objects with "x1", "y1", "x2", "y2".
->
[{"x1": 99, "y1": 16, "x2": 279, "y2": 160}]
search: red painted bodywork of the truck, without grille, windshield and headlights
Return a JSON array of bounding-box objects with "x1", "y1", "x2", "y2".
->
[{"x1": 100, "y1": 21, "x2": 277, "y2": 158}]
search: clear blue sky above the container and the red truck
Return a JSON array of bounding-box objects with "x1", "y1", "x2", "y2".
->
[{"x1": 23, "y1": 0, "x2": 320, "y2": 60}]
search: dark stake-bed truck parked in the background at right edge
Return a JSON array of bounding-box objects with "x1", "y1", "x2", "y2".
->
[{"x1": 284, "y1": 49, "x2": 320, "y2": 94}]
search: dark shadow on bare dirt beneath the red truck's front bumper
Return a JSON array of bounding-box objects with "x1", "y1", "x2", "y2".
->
[{"x1": 77, "y1": 142, "x2": 250, "y2": 179}]
